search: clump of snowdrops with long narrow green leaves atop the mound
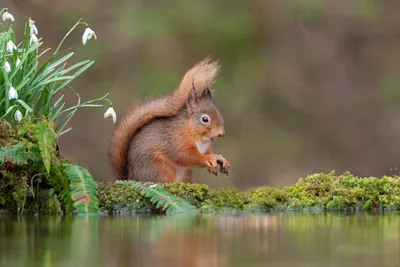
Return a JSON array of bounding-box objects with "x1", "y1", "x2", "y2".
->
[{"x1": 0, "y1": 9, "x2": 112, "y2": 136}]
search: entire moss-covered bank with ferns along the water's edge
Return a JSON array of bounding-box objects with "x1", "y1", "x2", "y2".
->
[{"x1": 0, "y1": 120, "x2": 400, "y2": 214}]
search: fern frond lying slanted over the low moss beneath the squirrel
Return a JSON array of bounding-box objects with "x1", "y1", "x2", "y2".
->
[{"x1": 115, "y1": 180, "x2": 196, "y2": 215}]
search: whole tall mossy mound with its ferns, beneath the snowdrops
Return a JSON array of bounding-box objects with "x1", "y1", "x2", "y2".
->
[{"x1": 0, "y1": 120, "x2": 98, "y2": 213}]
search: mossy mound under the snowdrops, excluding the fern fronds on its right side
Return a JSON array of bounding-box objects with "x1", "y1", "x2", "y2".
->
[{"x1": 0, "y1": 117, "x2": 76, "y2": 214}]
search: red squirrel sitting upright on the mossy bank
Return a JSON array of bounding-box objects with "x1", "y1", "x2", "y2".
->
[{"x1": 109, "y1": 58, "x2": 230, "y2": 183}]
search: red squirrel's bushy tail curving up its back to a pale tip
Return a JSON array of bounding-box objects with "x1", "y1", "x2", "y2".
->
[{"x1": 109, "y1": 58, "x2": 219, "y2": 180}]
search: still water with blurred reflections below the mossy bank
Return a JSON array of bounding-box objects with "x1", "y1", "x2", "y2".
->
[{"x1": 0, "y1": 214, "x2": 400, "y2": 267}]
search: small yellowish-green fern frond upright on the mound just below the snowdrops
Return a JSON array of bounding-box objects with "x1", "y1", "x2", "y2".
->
[{"x1": 36, "y1": 123, "x2": 56, "y2": 174}]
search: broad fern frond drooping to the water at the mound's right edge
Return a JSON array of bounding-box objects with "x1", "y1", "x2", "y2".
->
[{"x1": 64, "y1": 164, "x2": 99, "y2": 213}]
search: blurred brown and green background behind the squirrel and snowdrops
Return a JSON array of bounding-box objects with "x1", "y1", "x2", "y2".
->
[{"x1": 2, "y1": 0, "x2": 400, "y2": 189}]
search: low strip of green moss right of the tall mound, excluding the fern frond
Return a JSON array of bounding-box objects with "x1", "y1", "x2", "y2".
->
[{"x1": 94, "y1": 172, "x2": 400, "y2": 215}]
